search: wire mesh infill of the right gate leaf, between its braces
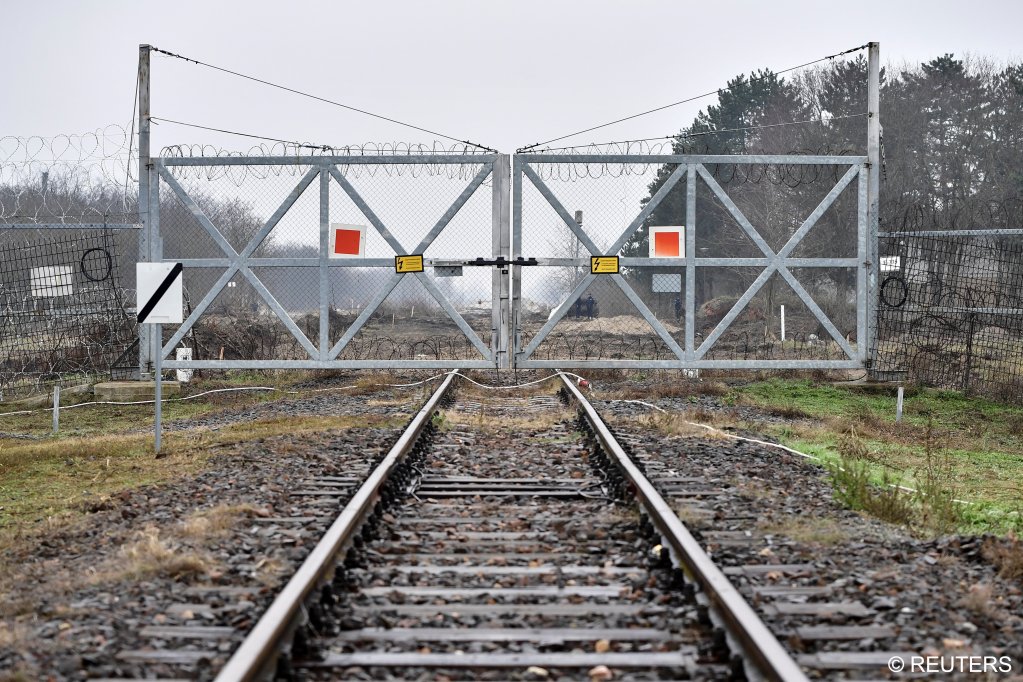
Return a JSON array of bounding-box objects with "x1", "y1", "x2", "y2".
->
[{"x1": 520, "y1": 157, "x2": 859, "y2": 367}]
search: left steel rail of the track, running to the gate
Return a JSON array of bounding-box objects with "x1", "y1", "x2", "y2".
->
[{"x1": 216, "y1": 372, "x2": 456, "y2": 682}]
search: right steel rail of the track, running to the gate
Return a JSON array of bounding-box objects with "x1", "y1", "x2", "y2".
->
[{"x1": 559, "y1": 372, "x2": 808, "y2": 682}]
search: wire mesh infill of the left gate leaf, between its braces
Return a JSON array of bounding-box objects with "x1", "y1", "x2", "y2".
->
[{"x1": 160, "y1": 155, "x2": 493, "y2": 361}]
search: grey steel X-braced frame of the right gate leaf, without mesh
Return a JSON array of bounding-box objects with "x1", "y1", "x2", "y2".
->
[{"x1": 512, "y1": 153, "x2": 876, "y2": 369}]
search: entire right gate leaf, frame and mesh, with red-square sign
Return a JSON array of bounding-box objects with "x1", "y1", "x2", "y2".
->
[{"x1": 513, "y1": 154, "x2": 872, "y2": 369}]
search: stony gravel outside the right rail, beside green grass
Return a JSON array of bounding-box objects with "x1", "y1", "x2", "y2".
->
[{"x1": 598, "y1": 401, "x2": 1023, "y2": 680}]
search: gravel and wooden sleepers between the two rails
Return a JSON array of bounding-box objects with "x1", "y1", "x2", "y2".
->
[{"x1": 309, "y1": 396, "x2": 728, "y2": 680}]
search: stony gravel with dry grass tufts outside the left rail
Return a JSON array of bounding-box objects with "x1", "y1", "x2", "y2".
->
[{"x1": 0, "y1": 378, "x2": 417, "y2": 680}]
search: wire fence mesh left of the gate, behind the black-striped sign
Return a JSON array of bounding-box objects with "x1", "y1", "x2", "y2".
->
[{"x1": 0, "y1": 229, "x2": 137, "y2": 398}]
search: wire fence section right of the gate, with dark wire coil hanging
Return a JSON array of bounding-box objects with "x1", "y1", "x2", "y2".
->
[{"x1": 875, "y1": 230, "x2": 1023, "y2": 402}]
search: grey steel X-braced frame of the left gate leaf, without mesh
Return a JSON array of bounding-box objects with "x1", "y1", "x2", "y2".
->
[{"x1": 143, "y1": 154, "x2": 509, "y2": 369}]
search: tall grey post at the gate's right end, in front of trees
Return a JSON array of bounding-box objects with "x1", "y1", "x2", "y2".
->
[{"x1": 857, "y1": 42, "x2": 881, "y2": 368}]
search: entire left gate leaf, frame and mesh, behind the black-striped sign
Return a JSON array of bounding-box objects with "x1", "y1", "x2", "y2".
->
[{"x1": 141, "y1": 153, "x2": 509, "y2": 369}]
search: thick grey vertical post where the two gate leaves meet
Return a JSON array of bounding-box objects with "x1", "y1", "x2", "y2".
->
[{"x1": 490, "y1": 154, "x2": 514, "y2": 369}]
